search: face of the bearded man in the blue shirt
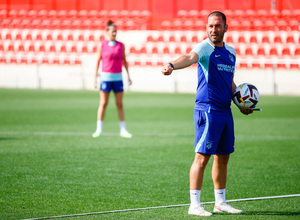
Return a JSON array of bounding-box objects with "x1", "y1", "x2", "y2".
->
[{"x1": 206, "y1": 15, "x2": 228, "y2": 47}]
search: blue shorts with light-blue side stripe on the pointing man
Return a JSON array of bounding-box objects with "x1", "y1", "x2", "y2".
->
[{"x1": 194, "y1": 110, "x2": 235, "y2": 154}]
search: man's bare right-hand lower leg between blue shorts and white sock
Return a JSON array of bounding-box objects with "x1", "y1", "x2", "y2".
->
[{"x1": 212, "y1": 154, "x2": 230, "y2": 189}]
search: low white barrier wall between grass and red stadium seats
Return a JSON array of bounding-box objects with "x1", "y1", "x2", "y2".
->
[{"x1": 0, "y1": 60, "x2": 300, "y2": 95}]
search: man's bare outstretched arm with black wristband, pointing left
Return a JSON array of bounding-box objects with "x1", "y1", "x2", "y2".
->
[{"x1": 161, "y1": 52, "x2": 198, "y2": 75}]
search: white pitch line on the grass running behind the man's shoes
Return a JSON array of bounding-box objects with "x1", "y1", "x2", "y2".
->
[{"x1": 24, "y1": 194, "x2": 300, "y2": 220}]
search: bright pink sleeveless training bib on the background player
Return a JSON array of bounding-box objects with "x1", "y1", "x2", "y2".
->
[{"x1": 101, "y1": 40, "x2": 124, "y2": 73}]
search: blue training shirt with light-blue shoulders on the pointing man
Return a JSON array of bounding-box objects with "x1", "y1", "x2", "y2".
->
[{"x1": 192, "y1": 39, "x2": 236, "y2": 112}]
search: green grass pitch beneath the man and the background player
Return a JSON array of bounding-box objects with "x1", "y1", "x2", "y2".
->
[{"x1": 0, "y1": 89, "x2": 300, "y2": 219}]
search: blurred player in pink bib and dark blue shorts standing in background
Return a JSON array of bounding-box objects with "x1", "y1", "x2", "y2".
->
[{"x1": 92, "y1": 20, "x2": 132, "y2": 138}]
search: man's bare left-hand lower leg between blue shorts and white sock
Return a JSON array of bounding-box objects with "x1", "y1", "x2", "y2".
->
[{"x1": 190, "y1": 153, "x2": 211, "y2": 190}]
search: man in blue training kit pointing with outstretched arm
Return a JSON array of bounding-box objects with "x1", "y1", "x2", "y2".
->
[{"x1": 161, "y1": 11, "x2": 253, "y2": 216}]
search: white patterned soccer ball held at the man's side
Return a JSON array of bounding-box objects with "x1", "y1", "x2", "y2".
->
[{"x1": 233, "y1": 83, "x2": 259, "y2": 108}]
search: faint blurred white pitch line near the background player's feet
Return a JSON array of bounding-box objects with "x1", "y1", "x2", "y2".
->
[{"x1": 0, "y1": 131, "x2": 300, "y2": 140}]
